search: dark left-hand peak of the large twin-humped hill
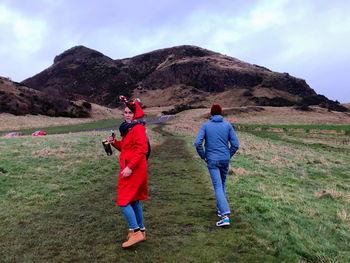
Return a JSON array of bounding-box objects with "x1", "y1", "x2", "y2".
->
[{"x1": 22, "y1": 46, "x2": 134, "y2": 105}]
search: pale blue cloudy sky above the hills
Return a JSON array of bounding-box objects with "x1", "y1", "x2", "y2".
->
[{"x1": 0, "y1": 0, "x2": 350, "y2": 103}]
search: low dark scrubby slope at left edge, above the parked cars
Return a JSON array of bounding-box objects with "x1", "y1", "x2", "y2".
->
[{"x1": 0, "y1": 77, "x2": 91, "y2": 117}]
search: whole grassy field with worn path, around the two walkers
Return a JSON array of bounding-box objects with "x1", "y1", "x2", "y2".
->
[{"x1": 0, "y1": 114, "x2": 350, "y2": 262}]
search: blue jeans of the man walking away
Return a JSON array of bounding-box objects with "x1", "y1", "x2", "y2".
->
[{"x1": 207, "y1": 160, "x2": 231, "y2": 216}]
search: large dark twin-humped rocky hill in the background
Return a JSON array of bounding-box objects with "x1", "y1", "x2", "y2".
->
[{"x1": 17, "y1": 46, "x2": 348, "y2": 112}]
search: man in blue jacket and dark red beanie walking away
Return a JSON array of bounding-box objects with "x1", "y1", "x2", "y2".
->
[{"x1": 194, "y1": 104, "x2": 239, "y2": 226}]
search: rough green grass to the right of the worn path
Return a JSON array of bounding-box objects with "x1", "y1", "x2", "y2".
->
[{"x1": 221, "y1": 132, "x2": 350, "y2": 262}]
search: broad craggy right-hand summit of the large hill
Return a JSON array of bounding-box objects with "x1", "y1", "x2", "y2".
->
[{"x1": 125, "y1": 46, "x2": 316, "y2": 97}]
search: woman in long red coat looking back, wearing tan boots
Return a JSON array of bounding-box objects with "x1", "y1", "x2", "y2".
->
[{"x1": 109, "y1": 96, "x2": 148, "y2": 248}]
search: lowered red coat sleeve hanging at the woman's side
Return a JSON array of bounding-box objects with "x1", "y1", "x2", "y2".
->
[{"x1": 128, "y1": 125, "x2": 148, "y2": 170}]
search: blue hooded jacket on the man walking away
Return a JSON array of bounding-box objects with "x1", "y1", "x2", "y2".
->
[{"x1": 194, "y1": 115, "x2": 239, "y2": 161}]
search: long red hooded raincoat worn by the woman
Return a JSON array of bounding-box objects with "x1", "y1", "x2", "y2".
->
[{"x1": 113, "y1": 103, "x2": 148, "y2": 206}]
